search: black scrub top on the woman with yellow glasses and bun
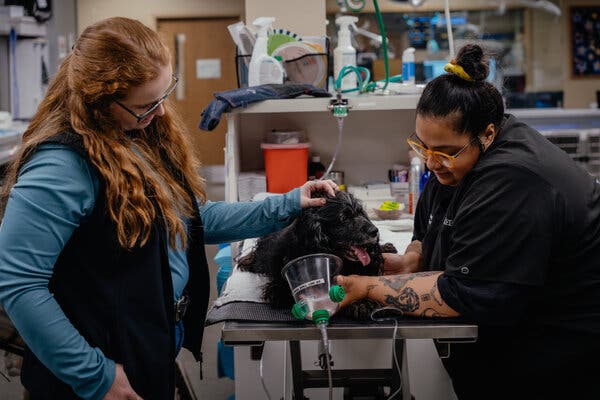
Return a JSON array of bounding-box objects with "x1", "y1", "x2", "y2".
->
[{"x1": 413, "y1": 115, "x2": 600, "y2": 393}]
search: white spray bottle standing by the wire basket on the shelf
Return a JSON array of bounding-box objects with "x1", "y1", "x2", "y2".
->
[{"x1": 248, "y1": 17, "x2": 284, "y2": 86}]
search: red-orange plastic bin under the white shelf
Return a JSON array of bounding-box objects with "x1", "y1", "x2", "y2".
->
[{"x1": 260, "y1": 143, "x2": 310, "y2": 193}]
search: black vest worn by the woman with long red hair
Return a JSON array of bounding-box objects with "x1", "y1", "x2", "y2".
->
[{"x1": 21, "y1": 133, "x2": 210, "y2": 400}]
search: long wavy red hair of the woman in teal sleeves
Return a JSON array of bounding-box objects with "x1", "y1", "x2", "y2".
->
[{"x1": 0, "y1": 17, "x2": 206, "y2": 248}]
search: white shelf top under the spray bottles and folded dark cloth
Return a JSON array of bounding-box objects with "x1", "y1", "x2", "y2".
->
[{"x1": 231, "y1": 94, "x2": 420, "y2": 114}]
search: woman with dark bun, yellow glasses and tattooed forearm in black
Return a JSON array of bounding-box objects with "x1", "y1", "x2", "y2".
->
[{"x1": 338, "y1": 45, "x2": 600, "y2": 400}]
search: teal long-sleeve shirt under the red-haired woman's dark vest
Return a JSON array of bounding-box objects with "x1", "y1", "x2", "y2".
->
[{"x1": 0, "y1": 144, "x2": 300, "y2": 399}]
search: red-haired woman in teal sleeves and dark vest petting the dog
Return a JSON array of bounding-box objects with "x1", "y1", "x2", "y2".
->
[{"x1": 0, "y1": 18, "x2": 336, "y2": 400}]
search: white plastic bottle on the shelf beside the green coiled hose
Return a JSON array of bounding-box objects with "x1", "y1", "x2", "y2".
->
[{"x1": 333, "y1": 15, "x2": 358, "y2": 90}]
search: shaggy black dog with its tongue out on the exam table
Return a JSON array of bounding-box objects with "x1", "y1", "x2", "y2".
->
[{"x1": 238, "y1": 191, "x2": 397, "y2": 314}]
